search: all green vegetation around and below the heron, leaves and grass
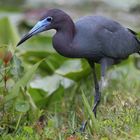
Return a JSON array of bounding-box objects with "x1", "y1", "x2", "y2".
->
[{"x1": 0, "y1": 15, "x2": 140, "y2": 140}]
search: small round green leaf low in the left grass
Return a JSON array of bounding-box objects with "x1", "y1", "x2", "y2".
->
[{"x1": 15, "y1": 100, "x2": 30, "y2": 113}]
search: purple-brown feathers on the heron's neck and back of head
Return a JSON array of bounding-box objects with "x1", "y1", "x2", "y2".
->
[{"x1": 49, "y1": 9, "x2": 75, "y2": 57}]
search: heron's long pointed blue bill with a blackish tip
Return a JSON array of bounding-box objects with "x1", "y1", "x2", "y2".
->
[{"x1": 17, "y1": 19, "x2": 50, "y2": 46}]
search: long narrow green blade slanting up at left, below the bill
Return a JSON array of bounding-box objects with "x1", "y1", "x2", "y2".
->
[{"x1": 5, "y1": 59, "x2": 44, "y2": 101}]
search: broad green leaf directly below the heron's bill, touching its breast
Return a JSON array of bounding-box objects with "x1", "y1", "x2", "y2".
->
[{"x1": 18, "y1": 35, "x2": 66, "y2": 74}]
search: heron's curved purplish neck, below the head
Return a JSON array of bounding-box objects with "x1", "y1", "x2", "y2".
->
[{"x1": 53, "y1": 19, "x2": 79, "y2": 57}]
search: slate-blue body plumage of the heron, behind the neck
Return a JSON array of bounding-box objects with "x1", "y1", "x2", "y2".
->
[{"x1": 74, "y1": 16, "x2": 140, "y2": 60}]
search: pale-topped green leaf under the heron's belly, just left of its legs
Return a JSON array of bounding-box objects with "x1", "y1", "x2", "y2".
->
[{"x1": 55, "y1": 59, "x2": 90, "y2": 81}]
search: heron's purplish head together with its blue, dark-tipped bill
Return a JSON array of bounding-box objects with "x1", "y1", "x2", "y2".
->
[{"x1": 17, "y1": 9, "x2": 70, "y2": 46}]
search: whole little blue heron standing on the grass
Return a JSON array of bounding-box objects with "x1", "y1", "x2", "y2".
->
[{"x1": 17, "y1": 9, "x2": 140, "y2": 131}]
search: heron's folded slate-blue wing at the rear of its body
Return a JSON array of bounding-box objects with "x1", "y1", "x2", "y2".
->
[{"x1": 97, "y1": 26, "x2": 140, "y2": 59}]
